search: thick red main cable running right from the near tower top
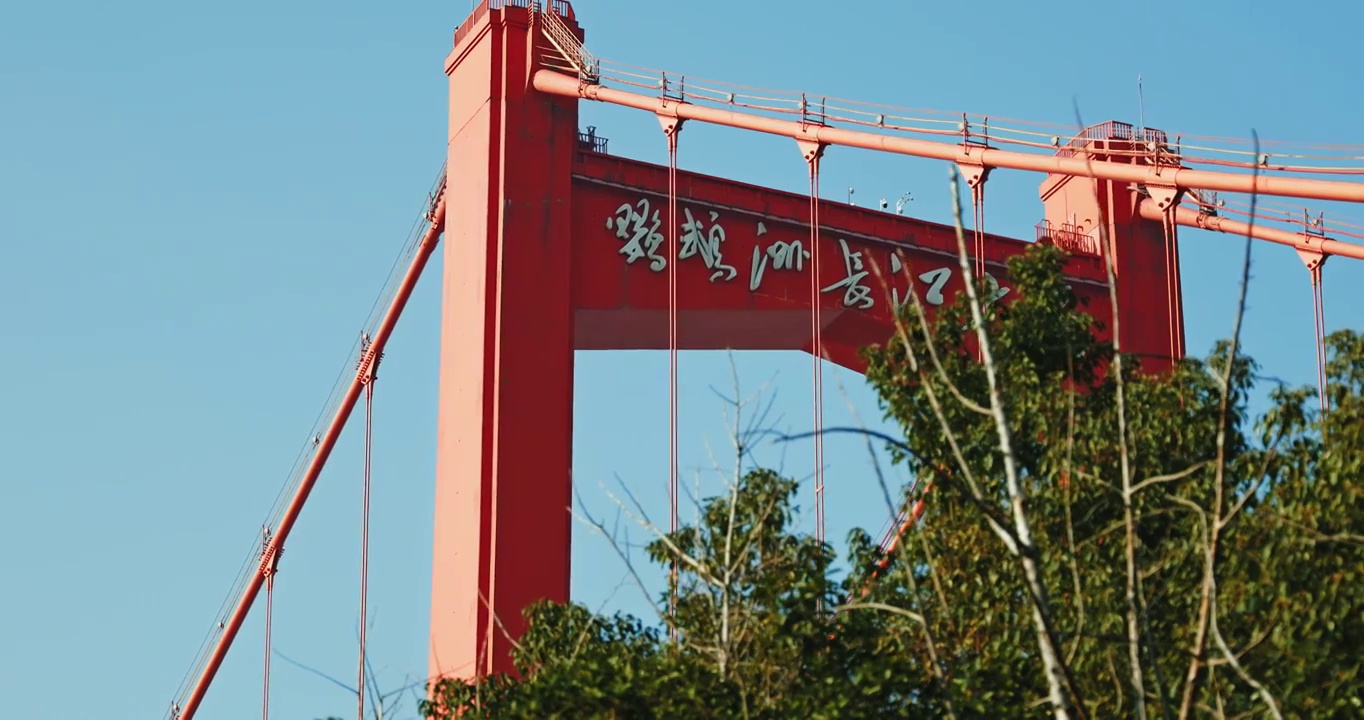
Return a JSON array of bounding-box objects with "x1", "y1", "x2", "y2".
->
[{"x1": 535, "y1": 70, "x2": 1364, "y2": 202}]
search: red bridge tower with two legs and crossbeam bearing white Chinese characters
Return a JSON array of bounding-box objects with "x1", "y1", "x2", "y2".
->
[{"x1": 430, "y1": 0, "x2": 1183, "y2": 676}]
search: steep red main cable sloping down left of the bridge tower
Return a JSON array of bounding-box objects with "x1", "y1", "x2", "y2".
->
[{"x1": 176, "y1": 189, "x2": 445, "y2": 720}]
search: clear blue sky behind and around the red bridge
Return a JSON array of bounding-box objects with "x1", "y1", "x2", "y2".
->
[{"x1": 0, "y1": 0, "x2": 1364, "y2": 720}]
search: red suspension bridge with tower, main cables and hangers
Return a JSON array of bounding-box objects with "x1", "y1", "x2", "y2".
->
[{"x1": 154, "y1": 0, "x2": 1364, "y2": 720}]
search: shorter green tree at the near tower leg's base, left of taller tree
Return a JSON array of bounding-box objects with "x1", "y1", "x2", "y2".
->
[{"x1": 427, "y1": 470, "x2": 921, "y2": 717}]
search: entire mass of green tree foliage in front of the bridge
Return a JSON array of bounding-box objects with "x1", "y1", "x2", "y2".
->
[{"x1": 423, "y1": 245, "x2": 1364, "y2": 719}]
